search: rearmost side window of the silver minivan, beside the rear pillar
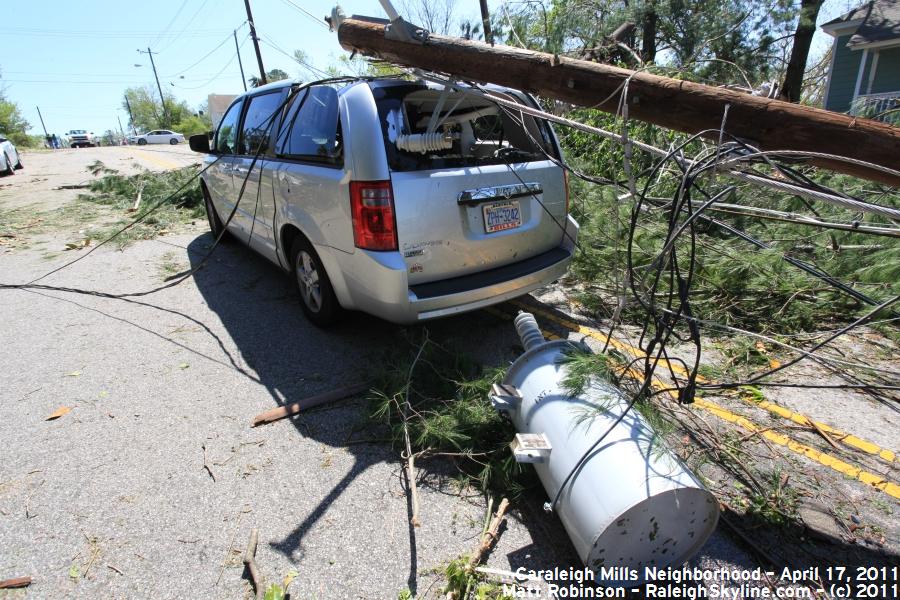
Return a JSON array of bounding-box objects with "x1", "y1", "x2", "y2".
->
[{"x1": 276, "y1": 85, "x2": 343, "y2": 164}]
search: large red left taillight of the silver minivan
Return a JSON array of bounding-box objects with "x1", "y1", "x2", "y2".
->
[{"x1": 350, "y1": 181, "x2": 397, "y2": 250}]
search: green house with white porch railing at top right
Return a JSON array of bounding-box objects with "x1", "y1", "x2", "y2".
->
[{"x1": 822, "y1": 0, "x2": 900, "y2": 123}]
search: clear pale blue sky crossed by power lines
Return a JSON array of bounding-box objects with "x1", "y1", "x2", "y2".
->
[{"x1": 0, "y1": 0, "x2": 851, "y2": 134}]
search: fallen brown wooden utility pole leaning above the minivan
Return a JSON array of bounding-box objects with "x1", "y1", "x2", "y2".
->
[{"x1": 338, "y1": 18, "x2": 900, "y2": 186}]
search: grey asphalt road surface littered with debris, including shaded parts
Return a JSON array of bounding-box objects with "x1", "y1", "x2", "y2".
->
[{"x1": 0, "y1": 146, "x2": 884, "y2": 599}]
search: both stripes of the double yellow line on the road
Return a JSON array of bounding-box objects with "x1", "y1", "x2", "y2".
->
[{"x1": 496, "y1": 300, "x2": 900, "y2": 499}]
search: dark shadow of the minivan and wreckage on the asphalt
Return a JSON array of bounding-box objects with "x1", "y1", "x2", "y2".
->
[{"x1": 188, "y1": 234, "x2": 578, "y2": 595}]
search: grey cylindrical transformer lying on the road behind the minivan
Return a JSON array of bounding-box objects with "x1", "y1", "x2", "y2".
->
[{"x1": 495, "y1": 313, "x2": 719, "y2": 586}]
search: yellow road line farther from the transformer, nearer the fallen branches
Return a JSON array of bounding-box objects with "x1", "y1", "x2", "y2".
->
[{"x1": 511, "y1": 300, "x2": 897, "y2": 463}]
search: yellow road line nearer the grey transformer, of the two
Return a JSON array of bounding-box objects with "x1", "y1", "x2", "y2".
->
[{"x1": 490, "y1": 301, "x2": 900, "y2": 499}]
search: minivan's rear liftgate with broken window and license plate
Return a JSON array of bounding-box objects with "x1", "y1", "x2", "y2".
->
[{"x1": 375, "y1": 84, "x2": 567, "y2": 285}]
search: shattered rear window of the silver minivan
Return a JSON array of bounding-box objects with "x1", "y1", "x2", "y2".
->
[{"x1": 372, "y1": 84, "x2": 558, "y2": 171}]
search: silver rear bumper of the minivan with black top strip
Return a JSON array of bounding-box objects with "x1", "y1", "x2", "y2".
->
[{"x1": 336, "y1": 217, "x2": 578, "y2": 324}]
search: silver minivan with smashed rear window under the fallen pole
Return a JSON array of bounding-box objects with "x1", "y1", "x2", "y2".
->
[{"x1": 191, "y1": 79, "x2": 578, "y2": 325}]
